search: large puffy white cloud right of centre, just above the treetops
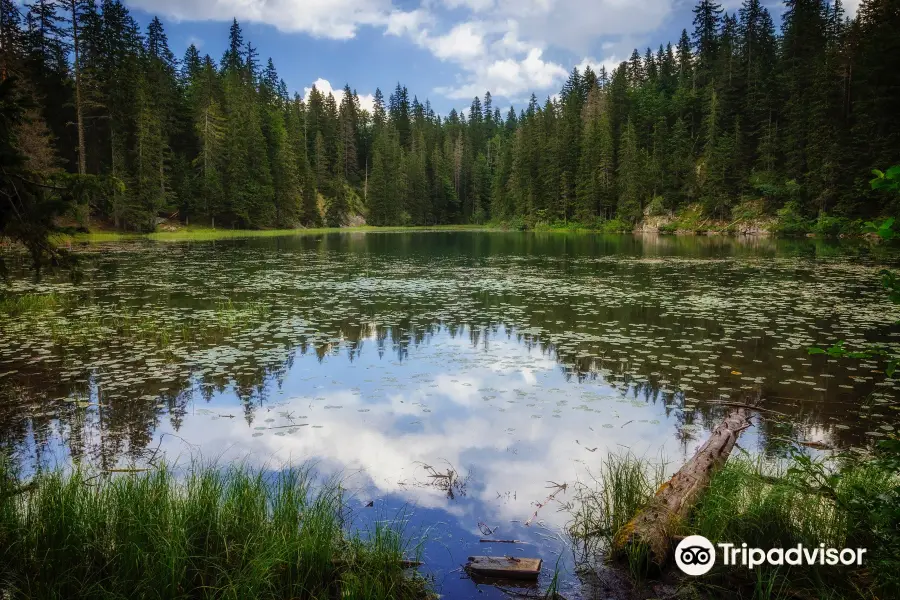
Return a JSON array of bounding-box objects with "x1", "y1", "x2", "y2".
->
[{"x1": 388, "y1": 0, "x2": 672, "y2": 101}]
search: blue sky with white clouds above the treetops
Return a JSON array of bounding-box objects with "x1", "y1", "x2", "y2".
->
[{"x1": 119, "y1": 0, "x2": 856, "y2": 114}]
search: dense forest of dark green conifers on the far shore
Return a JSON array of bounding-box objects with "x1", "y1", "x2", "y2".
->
[{"x1": 0, "y1": 0, "x2": 900, "y2": 231}]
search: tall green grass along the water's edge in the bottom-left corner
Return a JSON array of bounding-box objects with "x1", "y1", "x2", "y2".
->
[{"x1": 0, "y1": 463, "x2": 427, "y2": 600}]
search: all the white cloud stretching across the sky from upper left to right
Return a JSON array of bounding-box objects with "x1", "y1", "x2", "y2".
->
[{"x1": 129, "y1": 0, "x2": 696, "y2": 106}]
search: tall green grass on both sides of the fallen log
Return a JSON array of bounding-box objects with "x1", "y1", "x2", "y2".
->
[{"x1": 569, "y1": 453, "x2": 900, "y2": 600}]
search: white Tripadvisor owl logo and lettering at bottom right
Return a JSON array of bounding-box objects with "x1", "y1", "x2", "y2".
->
[{"x1": 675, "y1": 535, "x2": 866, "y2": 575}]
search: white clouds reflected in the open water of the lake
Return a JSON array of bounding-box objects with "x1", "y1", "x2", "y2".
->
[{"x1": 157, "y1": 338, "x2": 700, "y2": 541}]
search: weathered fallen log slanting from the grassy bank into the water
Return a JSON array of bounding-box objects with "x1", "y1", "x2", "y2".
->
[{"x1": 612, "y1": 407, "x2": 750, "y2": 567}]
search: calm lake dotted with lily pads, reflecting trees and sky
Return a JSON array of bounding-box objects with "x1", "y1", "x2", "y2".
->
[{"x1": 0, "y1": 231, "x2": 900, "y2": 598}]
